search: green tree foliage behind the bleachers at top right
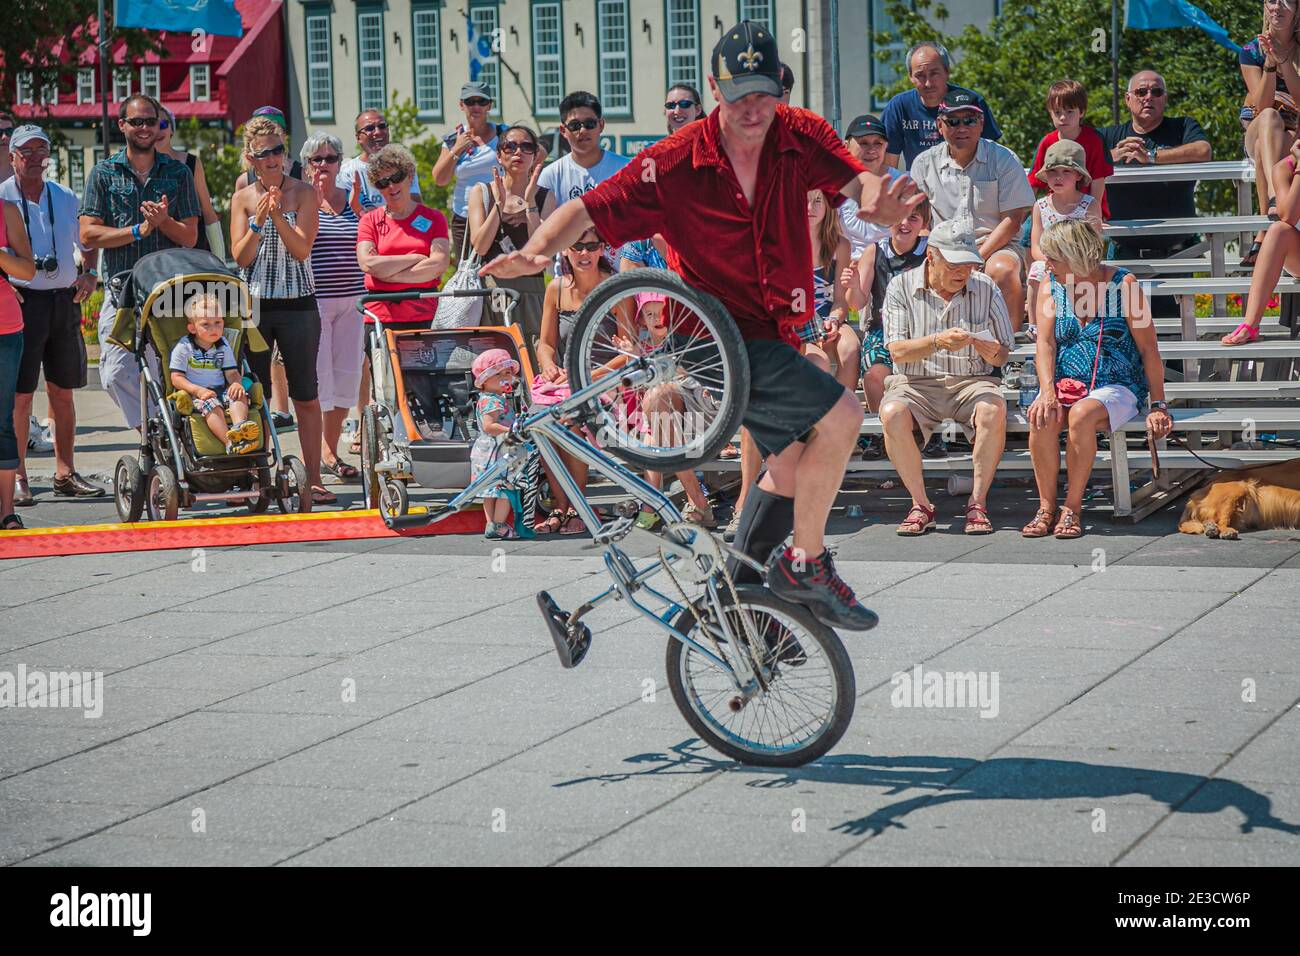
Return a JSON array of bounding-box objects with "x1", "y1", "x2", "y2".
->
[{"x1": 875, "y1": 0, "x2": 1261, "y2": 212}]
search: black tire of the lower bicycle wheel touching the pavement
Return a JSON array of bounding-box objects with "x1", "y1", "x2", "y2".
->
[{"x1": 666, "y1": 585, "x2": 857, "y2": 767}]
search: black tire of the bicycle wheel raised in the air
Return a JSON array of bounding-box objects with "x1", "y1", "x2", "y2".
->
[{"x1": 564, "y1": 269, "x2": 750, "y2": 472}]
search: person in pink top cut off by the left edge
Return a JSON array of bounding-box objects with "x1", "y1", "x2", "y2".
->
[{"x1": 0, "y1": 200, "x2": 36, "y2": 533}]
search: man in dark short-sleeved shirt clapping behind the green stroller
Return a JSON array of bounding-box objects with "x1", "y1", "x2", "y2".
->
[{"x1": 79, "y1": 94, "x2": 202, "y2": 428}]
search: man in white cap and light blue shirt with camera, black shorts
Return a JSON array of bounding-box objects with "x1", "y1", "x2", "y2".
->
[{"x1": 0, "y1": 126, "x2": 105, "y2": 506}]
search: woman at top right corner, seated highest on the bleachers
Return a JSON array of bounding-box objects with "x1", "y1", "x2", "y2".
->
[{"x1": 1232, "y1": 0, "x2": 1300, "y2": 269}]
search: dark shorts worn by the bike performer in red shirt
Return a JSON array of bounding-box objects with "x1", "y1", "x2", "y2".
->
[{"x1": 741, "y1": 339, "x2": 845, "y2": 458}]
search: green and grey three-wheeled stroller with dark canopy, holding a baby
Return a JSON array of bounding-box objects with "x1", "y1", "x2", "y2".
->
[{"x1": 109, "y1": 248, "x2": 312, "y2": 522}]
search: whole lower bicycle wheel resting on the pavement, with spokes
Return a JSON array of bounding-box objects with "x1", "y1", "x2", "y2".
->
[{"x1": 667, "y1": 587, "x2": 857, "y2": 767}]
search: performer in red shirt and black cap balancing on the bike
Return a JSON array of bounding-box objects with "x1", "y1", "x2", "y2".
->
[{"x1": 484, "y1": 21, "x2": 925, "y2": 630}]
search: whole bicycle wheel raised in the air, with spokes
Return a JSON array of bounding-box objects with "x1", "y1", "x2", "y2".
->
[{"x1": 566, "y1": 269, "x2": 749, "y2": 472}]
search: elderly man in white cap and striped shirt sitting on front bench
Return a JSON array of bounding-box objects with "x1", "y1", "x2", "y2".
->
[{"x1": 880, "y1": 220, "x2": 1014, "y2": 536}]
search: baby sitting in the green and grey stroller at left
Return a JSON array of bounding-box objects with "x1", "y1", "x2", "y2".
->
[{"x1": 168, "y1": 295, "x2": 261, "y2": 455}]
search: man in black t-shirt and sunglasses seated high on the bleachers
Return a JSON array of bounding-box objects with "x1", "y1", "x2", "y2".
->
[{"x1": 1097, "y1": 70, "x2": 1210, "y2": 300}]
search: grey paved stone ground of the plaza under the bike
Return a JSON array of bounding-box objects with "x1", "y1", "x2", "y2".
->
[{"x1": 0, "y1": 385, "x2": 1300, "y2": 865}]
